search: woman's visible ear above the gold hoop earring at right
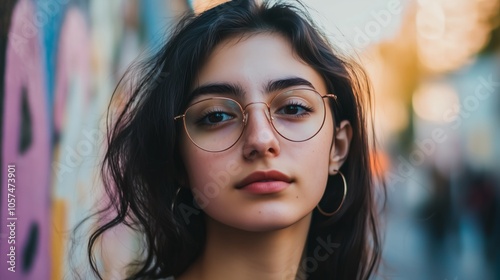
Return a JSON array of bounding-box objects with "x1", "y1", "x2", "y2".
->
[{"x1": 328, "y1": 120, "x2": 352, "y2": 175}]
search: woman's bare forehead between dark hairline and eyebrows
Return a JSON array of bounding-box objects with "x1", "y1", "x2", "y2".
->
[{"x1": 194, "y1": 33, "x2": 326, "y2": 93}]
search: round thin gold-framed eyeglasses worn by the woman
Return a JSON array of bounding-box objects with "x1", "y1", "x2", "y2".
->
[{"x1": 174, "y1": 89, "x2": 337, "y2": 152}]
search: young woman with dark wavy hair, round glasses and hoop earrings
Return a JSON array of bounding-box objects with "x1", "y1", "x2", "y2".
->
[{"x1": 89, "y1": 0, "x2": 380, "y2": 280}]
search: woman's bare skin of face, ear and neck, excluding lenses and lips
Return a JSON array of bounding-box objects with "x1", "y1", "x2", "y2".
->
[{"x1": 179, "y1": 33, "x2": 352, "y2": 280}]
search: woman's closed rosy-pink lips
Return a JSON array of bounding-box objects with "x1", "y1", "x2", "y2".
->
[{"x1": 236, "y1": 170, "x2": 293, "y2": 194}]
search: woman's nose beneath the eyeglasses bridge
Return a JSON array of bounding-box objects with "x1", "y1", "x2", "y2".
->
[{"x1": 242, "y1": 102, "x2": 280, "y2": 160}]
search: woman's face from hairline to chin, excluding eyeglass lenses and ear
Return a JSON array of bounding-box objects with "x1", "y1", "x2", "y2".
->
[{"x1": 181, "y1": 34, "x2": 333, "y2": 231}]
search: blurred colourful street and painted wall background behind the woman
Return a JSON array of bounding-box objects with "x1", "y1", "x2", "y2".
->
[{"x1": 0, "y1": 0, "x2": 500, "y2": 280}]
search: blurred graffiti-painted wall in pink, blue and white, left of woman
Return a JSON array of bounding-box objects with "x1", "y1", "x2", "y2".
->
[{"x1": 0, "y1": 0, "x2": 187, "y2": 280}]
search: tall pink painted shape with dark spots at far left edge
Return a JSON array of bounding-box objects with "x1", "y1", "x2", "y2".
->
[{"x1": 0, "y1": 0, "x2": 51, "y2": 280}]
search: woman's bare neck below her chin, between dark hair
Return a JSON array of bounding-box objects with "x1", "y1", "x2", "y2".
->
[{"x1": 179, "y1": 214, "x2": 311, "y2": 280}]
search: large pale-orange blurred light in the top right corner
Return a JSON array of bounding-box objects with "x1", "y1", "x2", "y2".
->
[{"x1": 416, "y1": 0, "x2": 500, "y2": 73}]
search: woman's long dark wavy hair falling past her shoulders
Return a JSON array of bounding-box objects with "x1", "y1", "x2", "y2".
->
[{"x1": 88, "y1": 0, "x2": 381, "y2": 279}]
